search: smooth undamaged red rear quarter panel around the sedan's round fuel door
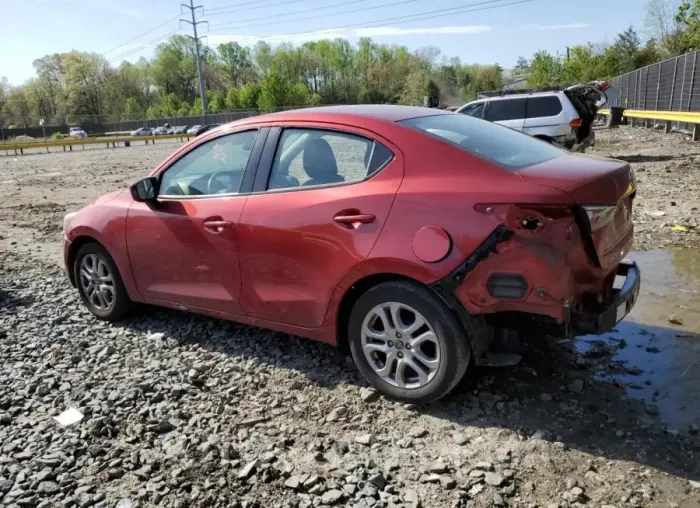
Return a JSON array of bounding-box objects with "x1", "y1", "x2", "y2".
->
[{"x1": 325, "y1": 126, "x2": 568, "y2": 324}]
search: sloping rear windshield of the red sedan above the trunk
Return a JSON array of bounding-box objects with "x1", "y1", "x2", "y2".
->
[{"x1": 399, "y1": 114, "x2": 564, "y2": 170}]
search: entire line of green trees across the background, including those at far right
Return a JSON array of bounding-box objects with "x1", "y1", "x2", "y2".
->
[{"x1": 0, "y1": 0, "x2": 700, "y2": 127}]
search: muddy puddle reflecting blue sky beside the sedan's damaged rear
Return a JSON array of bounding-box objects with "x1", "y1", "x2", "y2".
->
[{"x1": 577, "y1": 249, "x2": 700, "y2": 431}]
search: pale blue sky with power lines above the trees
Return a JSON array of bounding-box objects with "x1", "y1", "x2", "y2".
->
[{"x1": 0, "y1": 0, "x2": 646, "y2": 85}]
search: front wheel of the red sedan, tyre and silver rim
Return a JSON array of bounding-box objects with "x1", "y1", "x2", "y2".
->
[{"x1": 73, "y1": 243, "x2": 132, "y2": 321}]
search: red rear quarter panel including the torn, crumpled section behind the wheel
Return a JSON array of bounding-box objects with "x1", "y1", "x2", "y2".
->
[{"x1": 331, "y1": 125, "x2": 601, "y2": 326}]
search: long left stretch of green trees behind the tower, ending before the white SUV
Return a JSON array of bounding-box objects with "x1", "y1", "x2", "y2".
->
[{"x1": 0, "y1": 35, "x2": 502, "y2": 126}]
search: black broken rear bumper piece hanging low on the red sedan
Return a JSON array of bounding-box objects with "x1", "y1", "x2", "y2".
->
[{"x1": 571, "y1": 262, "x2": 641, "y2": 335}]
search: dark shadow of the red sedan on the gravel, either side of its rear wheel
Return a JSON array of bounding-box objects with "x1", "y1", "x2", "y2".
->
[{"x1": 117, "y1": 308, "x2": 700, "y2": 480}]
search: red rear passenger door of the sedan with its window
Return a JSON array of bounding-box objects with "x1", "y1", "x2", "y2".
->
[{"x1": 239, "y1": 124, "x2": 403, "y2": 328}]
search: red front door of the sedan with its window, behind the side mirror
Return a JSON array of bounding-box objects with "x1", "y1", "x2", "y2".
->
[{"x1": 126, "y1": 128, "x2": 267, "y2": 314}]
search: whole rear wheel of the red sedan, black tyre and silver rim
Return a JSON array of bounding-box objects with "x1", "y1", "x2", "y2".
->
[{"x1": 348, "y1": 281, "x2": 471, "y2": 403}]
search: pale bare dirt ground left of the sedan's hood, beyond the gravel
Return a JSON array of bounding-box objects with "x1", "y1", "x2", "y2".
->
[{"x1": 0, "y1": 141, "x2": 180, "y2": 263}]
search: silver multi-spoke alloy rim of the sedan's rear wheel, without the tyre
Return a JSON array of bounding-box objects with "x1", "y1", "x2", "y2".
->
[{"x1": 362, "y1": 302, "x2": 440, "y2": 389}]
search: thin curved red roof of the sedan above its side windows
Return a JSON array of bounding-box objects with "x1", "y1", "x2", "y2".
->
[{"x1": 236, "y1": 104, "x2": 454, "y2": 124}]
